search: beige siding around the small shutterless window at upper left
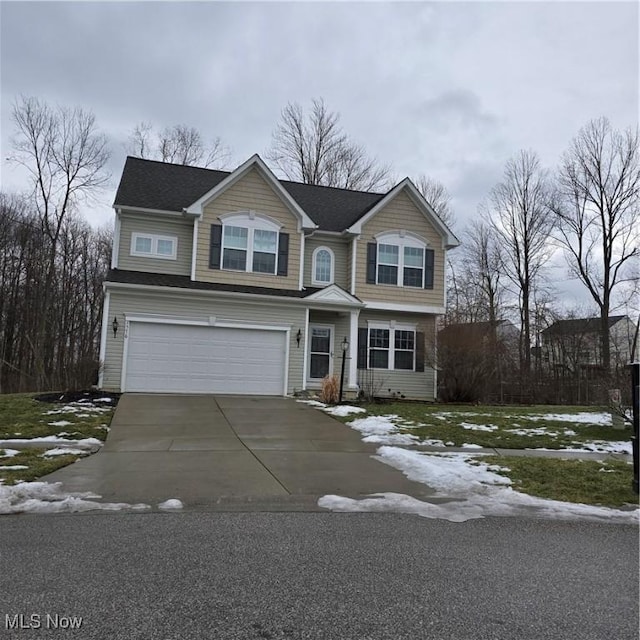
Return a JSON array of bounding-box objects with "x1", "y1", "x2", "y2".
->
[{"x1": 118, "y1": 212, "x2": 193, "y2": 276}]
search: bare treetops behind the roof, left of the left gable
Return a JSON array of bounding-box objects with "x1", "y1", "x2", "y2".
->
[{"x1": 126, "y1": 122, "x2": 231, "y2": 169}]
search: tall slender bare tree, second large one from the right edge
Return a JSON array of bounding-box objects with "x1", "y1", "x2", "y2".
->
[{"x1": 485, "y1": 151, "x2": 552, "y2": 377}]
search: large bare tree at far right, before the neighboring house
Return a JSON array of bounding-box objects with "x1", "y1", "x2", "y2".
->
[{"x1": 551, "y1": 118, "x2": 640, "y2": 372}]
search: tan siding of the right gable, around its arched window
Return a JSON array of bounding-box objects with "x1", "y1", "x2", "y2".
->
[{"x1": 355, "y1": 192, "x2": 445, "y2": 306}]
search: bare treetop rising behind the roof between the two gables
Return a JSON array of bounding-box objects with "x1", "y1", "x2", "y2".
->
[{"x1": 266, "y1": 98, "x2": 390, "y2": 191}]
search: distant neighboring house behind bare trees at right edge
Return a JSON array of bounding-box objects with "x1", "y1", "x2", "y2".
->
[{"x1": 540, "y1": 316, "x2": 636, "y2": 373}]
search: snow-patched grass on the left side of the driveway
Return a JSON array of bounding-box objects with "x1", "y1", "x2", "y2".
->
[{"x1": 0, "y1": 393, "x2": 115, "y2": 485}]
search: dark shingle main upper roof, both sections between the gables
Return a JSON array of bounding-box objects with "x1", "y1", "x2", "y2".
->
[{"x1": 114, "y1": 156, "x2": 385, "y2": 231}]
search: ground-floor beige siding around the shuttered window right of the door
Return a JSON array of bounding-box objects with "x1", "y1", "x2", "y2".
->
[{"x1": 358, "y1": 311, "x2": 436, "y2": 401}]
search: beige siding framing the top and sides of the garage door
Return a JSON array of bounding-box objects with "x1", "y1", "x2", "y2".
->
[{"x1": 103, "y1": 285, "x2": 305, "y2": 393}]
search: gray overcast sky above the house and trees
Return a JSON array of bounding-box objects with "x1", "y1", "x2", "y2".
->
[{"x1": 0, "y1": 1, "x2": 639, "y2": 308}]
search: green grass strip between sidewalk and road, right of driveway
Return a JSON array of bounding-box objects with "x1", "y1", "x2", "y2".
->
[{"x1": 478, "y1": 456, "x2": 638, "y2": 507}]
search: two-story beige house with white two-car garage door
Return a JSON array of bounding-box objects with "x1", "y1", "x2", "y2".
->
[{"x1": 100, "y1": 155, "x2": 458, "y2": 400}]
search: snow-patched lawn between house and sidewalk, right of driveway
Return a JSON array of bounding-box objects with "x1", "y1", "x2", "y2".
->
[{"x1": 352, "y1": 402, "x2": 632, "y2": 449}]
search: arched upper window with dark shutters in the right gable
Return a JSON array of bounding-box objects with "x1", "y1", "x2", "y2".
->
[{"x1": 367, "y1": 231, "x2": 434, "y2": 289}]
